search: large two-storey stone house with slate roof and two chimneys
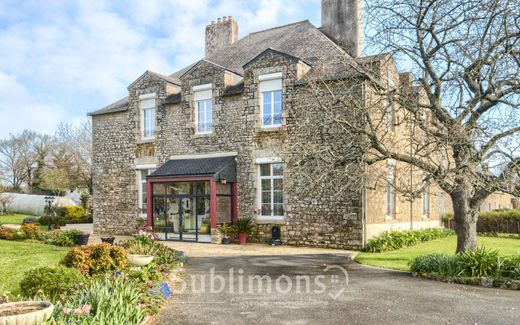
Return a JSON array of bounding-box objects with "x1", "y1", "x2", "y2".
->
[{"x1": 89, "y1": 0, "x2": 516, "y2": 248}]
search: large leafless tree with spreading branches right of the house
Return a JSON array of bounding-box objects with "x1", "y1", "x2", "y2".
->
[{"x1": 287, "y1": 0, "x2": 520, "y2": 252}]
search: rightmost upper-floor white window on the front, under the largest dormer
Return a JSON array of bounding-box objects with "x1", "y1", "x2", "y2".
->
[{"x1": 258, "y1": 72, "x2": 283, "y2": 127}]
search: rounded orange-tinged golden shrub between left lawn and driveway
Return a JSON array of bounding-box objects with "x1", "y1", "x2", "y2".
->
[{"x1": 62, "y1": 244, "x2": 128, "y2": 275}]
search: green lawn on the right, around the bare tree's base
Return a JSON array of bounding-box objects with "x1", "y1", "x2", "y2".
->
[{"x1": 356, "y1": 236, "x2": 520, "y2": 271}]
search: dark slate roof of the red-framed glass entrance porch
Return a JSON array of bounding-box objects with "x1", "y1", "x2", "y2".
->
[{"x1": 148, "y1": 156, "x2": 237, "y2": 182}]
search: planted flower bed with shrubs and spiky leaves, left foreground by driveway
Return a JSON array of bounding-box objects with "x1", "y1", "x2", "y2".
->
[{"x1": 2, "y1": 235, "x2": 187, "y2": 324}]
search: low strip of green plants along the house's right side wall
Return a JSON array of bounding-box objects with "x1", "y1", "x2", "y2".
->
[{"x1": 365, "y1": 228, "x2": 453, "y2": 253}]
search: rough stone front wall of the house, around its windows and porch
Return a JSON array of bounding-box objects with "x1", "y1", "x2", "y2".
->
[{"x1": 93, "y1": 51, "x2": 362, "y2": 248}]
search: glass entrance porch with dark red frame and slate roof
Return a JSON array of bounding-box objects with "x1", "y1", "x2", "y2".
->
[{"x1": 146, "y1": 156, "x2": 238, "y2": 242}]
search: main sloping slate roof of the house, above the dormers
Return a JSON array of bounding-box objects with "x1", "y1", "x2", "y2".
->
[{"x1": 89, "y1": 20, "x2": 356, "y2": 116}]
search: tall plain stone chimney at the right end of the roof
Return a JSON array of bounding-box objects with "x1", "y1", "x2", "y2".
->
[{"x1": 321, "y1": 0, "x2": 362, "y2": 58}]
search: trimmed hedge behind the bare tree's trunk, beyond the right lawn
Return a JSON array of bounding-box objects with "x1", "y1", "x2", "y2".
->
[{"x1": 442, "y1": 210, "x2": 520, "y2": 234}]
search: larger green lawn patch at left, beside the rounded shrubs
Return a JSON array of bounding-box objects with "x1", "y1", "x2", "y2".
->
[{"x1": 0, "y1": 240, "x2": 69, "y2": 295}]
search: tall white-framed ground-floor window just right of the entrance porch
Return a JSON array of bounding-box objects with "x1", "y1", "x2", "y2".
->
[{"x1": 258, "y1": 161, "x2": 284, "y2": 220}]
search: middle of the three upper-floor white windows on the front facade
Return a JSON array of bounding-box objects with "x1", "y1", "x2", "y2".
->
[{"x1": 193, "y1": 84, "x2": 213, "y2": 134}]
